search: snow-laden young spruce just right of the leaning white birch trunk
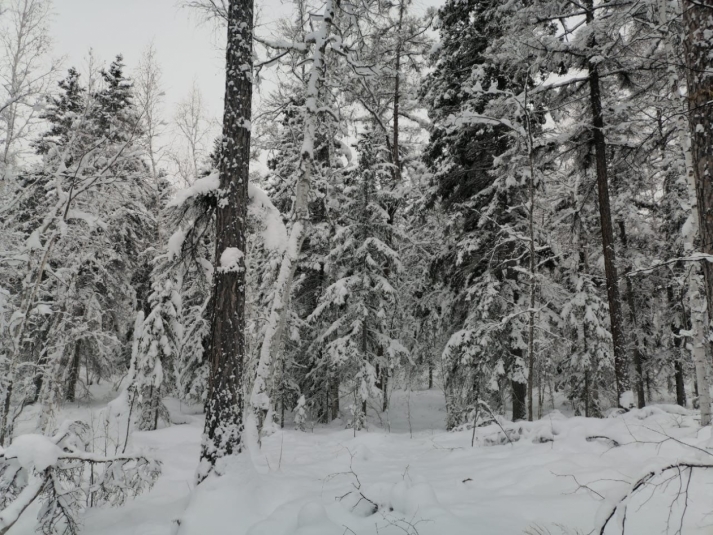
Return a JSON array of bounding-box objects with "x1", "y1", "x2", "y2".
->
[{"x1": 311, "y1": 132, "x2": 406, "y2": 429}]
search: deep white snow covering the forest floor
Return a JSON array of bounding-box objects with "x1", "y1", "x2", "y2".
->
[{"x1": 10, "y1": 389, "x2": 713, "y2": 535}]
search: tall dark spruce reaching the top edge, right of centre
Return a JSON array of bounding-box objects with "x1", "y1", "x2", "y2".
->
[{"x1": 423, "y1": 1, "x2": 529, "y2": 423}]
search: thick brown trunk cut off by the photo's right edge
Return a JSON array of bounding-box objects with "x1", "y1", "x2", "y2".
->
[{"x1": 683, "y1": 0, "x2": 713, "y2": 328}]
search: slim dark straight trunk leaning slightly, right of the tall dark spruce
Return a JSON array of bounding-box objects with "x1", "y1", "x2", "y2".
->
[{"x1": 585, "y1": 0, "x2": 626, "y2": 406}]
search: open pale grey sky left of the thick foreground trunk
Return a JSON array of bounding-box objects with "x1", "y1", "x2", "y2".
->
[{"x1": 52, "y1": 0, "x2": 228, "y2": 118}]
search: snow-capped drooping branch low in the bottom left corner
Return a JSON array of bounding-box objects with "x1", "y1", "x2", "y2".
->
[{"x1": 0, "y1": 422, "x2": 161, "y2": 535}]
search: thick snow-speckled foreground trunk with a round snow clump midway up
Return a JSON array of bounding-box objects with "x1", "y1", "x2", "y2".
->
[{"x1": 198, "y1": 0, "x2": 253, "y2": 480}]
